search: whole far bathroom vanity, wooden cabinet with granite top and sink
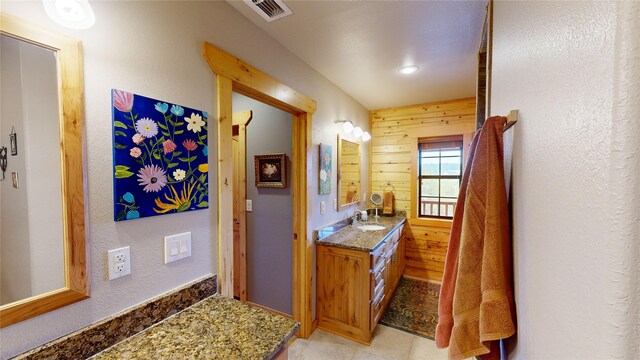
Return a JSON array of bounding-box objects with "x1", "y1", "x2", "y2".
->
[{"x1": 316, "y1": 213, "x2": 406, "y2": 344}]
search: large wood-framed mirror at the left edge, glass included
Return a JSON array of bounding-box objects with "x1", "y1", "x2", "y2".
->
[{"x1": 0, "y1": 13, "x2": 89, "y2": 327}]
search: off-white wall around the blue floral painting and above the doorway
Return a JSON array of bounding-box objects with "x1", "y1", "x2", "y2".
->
[{"x1": 0, "y1": 1, "x2": 369, "y2": 358}]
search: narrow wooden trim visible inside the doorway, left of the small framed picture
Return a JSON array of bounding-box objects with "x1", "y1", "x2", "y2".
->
[{"x1": 232, "y1": 110, "x2": 253, "y2": 301}]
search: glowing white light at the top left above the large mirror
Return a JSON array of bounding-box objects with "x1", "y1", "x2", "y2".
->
[{"x1": 42, "y1": 0, "x2": 96, "y2": 30}]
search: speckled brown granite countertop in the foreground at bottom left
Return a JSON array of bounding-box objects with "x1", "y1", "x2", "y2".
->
[{"x1": 90, "y1": 295, "x2": 300, "y2": 360}]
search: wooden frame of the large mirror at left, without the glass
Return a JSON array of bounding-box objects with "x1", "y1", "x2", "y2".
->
[{"x1": 0, "y1": 13, "x2": 89, "y2": 328}]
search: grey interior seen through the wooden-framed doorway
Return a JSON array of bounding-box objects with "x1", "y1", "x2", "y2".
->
[{"x1": 232, "y1": 92, "x2": 293, "y2": 316}]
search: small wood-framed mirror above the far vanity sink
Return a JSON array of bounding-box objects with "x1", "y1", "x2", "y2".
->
[{"x1": 337, "y1": 135, "x2": 361, "y2": 211}]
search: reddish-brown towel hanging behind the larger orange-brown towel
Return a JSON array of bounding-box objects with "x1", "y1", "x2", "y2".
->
[{"x1": 436, "y1": 130, "x2": 482, "y2": 349}]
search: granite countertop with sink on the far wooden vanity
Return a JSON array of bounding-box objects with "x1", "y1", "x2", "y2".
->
[{"x1": 316, "y1": 212, "x2": 407, "y2": 251}]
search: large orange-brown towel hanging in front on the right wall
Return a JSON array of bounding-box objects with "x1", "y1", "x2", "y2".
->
[{"x1": 436, "y1": 116, "x2": 515, "y2": 359}]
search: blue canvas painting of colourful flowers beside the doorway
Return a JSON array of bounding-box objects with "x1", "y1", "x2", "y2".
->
[{"x1": 112, "y1": 89, "x2": 209, "y2": 221}]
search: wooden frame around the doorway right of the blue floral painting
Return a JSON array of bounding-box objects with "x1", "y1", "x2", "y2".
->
[{"x1": 203, "y1": 42, "x2": 317, "y2": 339}]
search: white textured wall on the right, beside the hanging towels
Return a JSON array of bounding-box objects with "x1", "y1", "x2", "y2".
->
[{"x1": 491, "y1": 1, "x2": 640, "y2": 359}]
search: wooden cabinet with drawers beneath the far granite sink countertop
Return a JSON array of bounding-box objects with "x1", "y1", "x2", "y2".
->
[{"x1": 317, "y1": 225, "x2": 405, "y2": 344}]
